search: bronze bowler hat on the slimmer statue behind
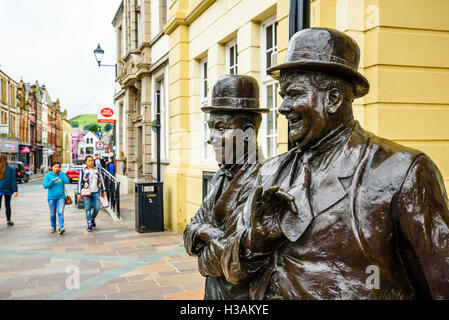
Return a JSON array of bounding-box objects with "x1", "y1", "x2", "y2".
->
[{"x1": 201, "y1": 74, "x2": 269, "y2": 113}]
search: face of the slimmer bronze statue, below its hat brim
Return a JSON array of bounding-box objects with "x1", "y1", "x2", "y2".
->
[{"x1": 207, "y1": 112, "x2": 254, "y2": 164}]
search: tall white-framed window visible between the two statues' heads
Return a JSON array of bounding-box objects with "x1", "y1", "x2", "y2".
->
[{"x1": 261, "y1": 17, "x2": 278, "y2": 157}]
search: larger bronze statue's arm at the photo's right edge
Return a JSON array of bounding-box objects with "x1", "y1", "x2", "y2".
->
[{"x1": 394, "y1": 155, "x2": 449, "y2": 299}]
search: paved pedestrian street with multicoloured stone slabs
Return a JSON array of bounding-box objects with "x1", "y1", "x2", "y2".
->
[{"x1": 0, "y1": 178, "x2": 204, "y2": 300}]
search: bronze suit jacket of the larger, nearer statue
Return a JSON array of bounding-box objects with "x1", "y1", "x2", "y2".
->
[{"x1": 222, "y1": 123, "x2": 449, "y2": 299}]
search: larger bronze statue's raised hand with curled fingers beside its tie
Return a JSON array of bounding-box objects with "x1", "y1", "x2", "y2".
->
[{"x1": 251, "y1": 186, "x2": 298, "y2": 251}]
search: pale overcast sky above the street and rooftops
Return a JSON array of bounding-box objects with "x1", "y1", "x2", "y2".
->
[{"x1": 0, "y1": 0, "x2": 121, "y2": 118}]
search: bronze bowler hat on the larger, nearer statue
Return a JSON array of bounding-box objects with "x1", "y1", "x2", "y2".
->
[{"x1": 267, "y1": 28, "x2": 369, "y2": 98}]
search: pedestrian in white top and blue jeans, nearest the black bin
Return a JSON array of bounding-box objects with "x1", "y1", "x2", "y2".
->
[{"x1": 77, "y1": 156, "x2": 107, "y2": 232}]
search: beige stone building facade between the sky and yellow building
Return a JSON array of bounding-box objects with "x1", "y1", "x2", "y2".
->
[{"x1": 112, "y1": 0, "x2": 169, "y2": 192}]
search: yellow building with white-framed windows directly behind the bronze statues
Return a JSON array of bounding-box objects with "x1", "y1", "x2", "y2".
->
[{"x1": 163, "y1": 0, "x2": 449, "y2": 232}]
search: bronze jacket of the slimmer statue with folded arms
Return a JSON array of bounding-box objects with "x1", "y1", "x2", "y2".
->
[{"x1": 184, "y1": 159, "x2": 263, "y2": 300}]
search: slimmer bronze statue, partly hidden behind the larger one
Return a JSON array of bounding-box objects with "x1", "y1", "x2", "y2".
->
[{"x1": 184, "y1": 75, "x2": 268, "y2": 300}]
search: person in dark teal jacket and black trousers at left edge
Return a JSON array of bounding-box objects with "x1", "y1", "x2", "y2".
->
[{"x1": 0, "y1": 154, "x2": 19, "y2": 227}]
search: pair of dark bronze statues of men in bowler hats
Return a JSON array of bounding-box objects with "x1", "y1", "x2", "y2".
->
[{"x1": 184, "y1": 28, "x2": 449, "y2": 300}]
